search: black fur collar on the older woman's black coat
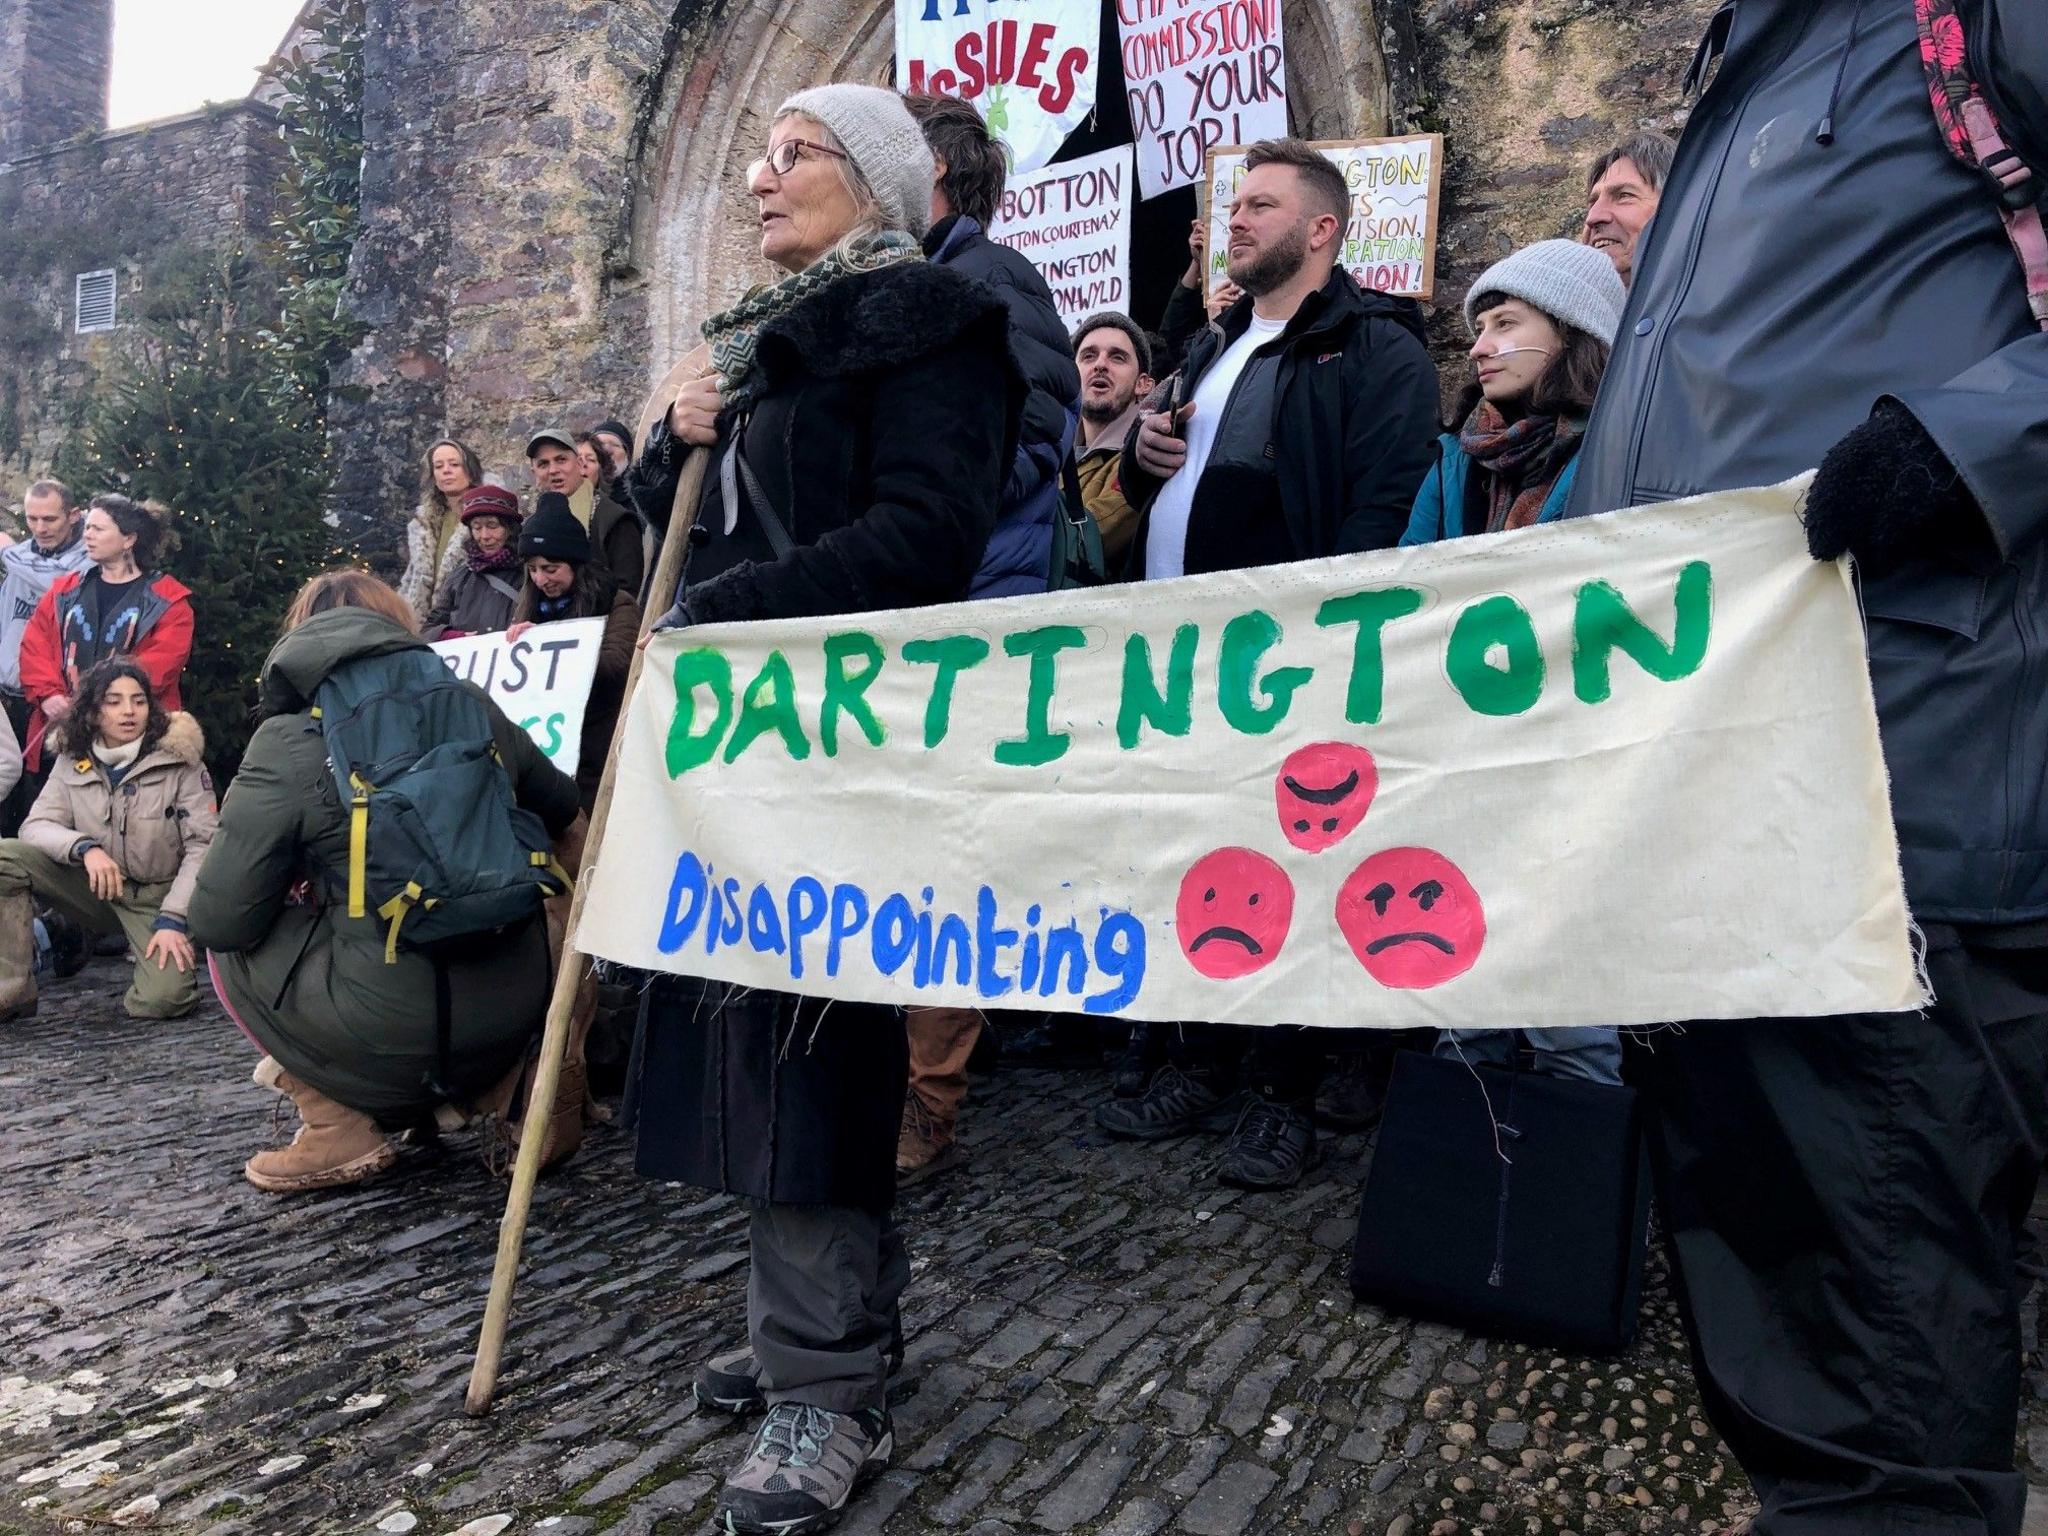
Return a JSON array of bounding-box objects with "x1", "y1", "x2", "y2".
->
[{"x1": 756, "y1": 262, "x2": 1010, "y2": 385}]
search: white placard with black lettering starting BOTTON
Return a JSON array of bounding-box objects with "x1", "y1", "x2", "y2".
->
[{"x1": 989, "y1": 143, "x2": 1130, "y2": 326}]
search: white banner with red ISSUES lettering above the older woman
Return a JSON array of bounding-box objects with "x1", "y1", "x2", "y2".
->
[{"x1": 895, "y1": 0, "x2": 1102, "y2": 172}]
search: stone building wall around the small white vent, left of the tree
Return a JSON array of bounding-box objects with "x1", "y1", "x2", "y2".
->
[{"x1": 0, "y1": 102, "x2": 283, "y2": 510}]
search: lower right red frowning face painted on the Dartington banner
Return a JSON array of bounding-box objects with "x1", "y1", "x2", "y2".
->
[{"x1": 1337, "y1": 848, "x2": 1487, "y2": 987}]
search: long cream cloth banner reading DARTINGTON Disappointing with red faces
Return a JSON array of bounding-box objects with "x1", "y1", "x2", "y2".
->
[{"x1": 575, "y1": 483, "x2": 1925, "y2": 1028}]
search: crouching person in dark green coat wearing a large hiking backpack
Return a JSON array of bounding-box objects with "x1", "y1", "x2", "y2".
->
[{"x1": 188, "y1": 571, "x2": 578, "y2": 1194}]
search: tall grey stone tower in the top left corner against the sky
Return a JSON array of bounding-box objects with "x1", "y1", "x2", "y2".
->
[{"x1": 0, "y1": 0, "x2": 115, "y2": 160}]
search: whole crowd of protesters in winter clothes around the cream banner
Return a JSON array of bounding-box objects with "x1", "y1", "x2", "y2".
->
[{"x1": 0, "y1": 0, "x2": 2048, "y2": 1536}]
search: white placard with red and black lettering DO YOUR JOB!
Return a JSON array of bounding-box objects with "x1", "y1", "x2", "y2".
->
[{"x1": 1116, "y1": 0, "x2": 1286, "y2": 197}]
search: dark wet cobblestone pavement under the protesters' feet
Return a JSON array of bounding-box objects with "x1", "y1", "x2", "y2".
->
[{"x1": 0, "y1": 965, "x2": 2048, "y2": 1536}]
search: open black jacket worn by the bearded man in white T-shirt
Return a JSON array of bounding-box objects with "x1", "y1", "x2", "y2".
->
[{"x1": 1120, "y1": 268, "x2": 1438, "y2": 575}]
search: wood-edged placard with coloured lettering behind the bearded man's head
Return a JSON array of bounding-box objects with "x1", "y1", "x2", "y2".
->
[{"x1": 1202, "y1": 133, "x2": 1444, "y2": 299}]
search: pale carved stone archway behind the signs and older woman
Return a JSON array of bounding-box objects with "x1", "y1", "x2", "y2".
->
[{"x1": 633, "y1": 0, "x2": 1391, "y2": 381}]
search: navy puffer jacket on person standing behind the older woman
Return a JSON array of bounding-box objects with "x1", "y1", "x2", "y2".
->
[{"x1": 924, "y1": 215, "x2": 1081, "y2": 598}]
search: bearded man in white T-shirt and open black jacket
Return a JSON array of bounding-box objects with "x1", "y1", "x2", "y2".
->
[{"x1": 1096, "y1": 139, "x2": 1438, "y2": 1190}]
